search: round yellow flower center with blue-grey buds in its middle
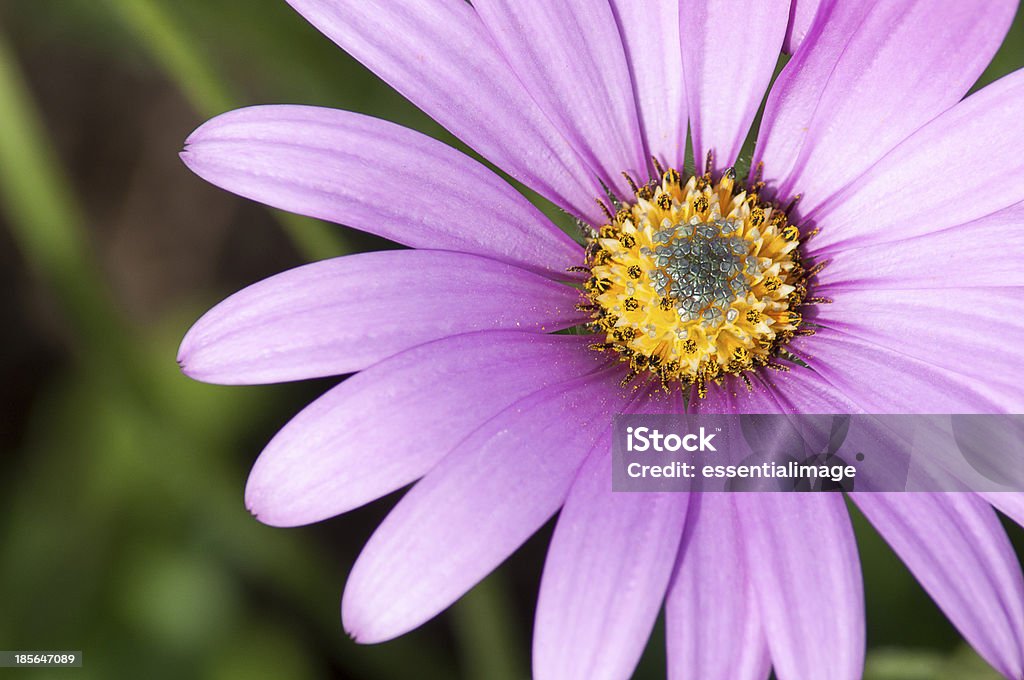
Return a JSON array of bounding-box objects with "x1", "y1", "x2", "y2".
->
[{"x1": 581, "y1": 170, "x2": 825, "y2": 397}]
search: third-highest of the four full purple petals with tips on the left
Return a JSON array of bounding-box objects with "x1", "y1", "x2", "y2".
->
[{"x1": 246, "y1": 331, "x2": 601, "y2": 526}]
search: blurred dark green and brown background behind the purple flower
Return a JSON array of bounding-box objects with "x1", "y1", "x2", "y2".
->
[{"x1": 0, "y1": 0, "x2": 1024, "y2": 680}]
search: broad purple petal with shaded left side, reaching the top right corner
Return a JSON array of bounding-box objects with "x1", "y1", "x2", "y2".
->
[{"x1": 755, "y1": 0, "x2": 1017, "y2": 213}]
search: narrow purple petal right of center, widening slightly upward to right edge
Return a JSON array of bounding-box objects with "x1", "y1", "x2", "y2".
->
[{"x1": 815, "y1": 203, "x2": 1024, "y2": 288}]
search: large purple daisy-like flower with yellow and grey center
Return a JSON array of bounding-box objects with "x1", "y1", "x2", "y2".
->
[{"x1": 180, "y1": 0, "x2": 1024, "y2": 680}]
